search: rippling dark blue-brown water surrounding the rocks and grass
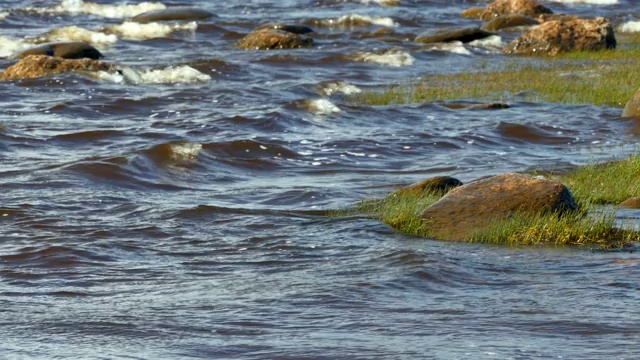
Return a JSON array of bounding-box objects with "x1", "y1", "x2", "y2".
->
[{"x1": 0, "y1": 0, "x2": 640, "y2": 359}]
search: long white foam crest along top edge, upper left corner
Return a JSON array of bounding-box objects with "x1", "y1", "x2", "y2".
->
[{"x1": 39, "y1": 0, "x2": 167, "y2": 18}]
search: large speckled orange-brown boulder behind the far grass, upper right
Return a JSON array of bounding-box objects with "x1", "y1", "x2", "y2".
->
[{"x1": 503, "y1": 17, "x2": 616, "y2": 56}]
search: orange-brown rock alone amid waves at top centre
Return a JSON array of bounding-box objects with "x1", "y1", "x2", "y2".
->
[{"x1": 236, "y1": 29, "x2": 313, "y2": 50}]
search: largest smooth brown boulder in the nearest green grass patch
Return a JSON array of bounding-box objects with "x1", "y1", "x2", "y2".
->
[{"x1": 422, "y1": 173, "x2": 578, "y2": 240}]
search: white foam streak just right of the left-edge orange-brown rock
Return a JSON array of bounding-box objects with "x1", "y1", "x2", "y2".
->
[{"x1": 97, "y1": 65, "x2": 211, "y2": 85}]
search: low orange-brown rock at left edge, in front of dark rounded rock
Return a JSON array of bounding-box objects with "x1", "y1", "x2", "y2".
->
[{"x1": 0, "y1": 55, "x2": 114, "y2": 80}]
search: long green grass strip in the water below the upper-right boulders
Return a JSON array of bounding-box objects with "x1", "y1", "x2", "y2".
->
[{"x1": 352, "y1": 35, "x2": 640, "y2": 107}]
